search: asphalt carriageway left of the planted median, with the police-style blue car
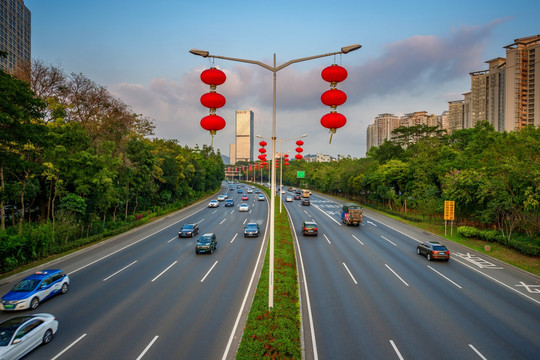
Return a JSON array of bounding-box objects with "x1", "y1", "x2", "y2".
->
[{"x1": 0, "y1": 184, "x2": 269, "y2": 360}]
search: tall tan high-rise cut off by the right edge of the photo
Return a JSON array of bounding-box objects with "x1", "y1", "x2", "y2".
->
[{"x1": 505, "y1": 35, "x2": 540, "y2": 131}]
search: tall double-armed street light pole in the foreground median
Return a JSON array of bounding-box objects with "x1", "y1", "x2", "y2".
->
[{"x1": 189, "y1": 44, "x2": 362, "y2": 309}]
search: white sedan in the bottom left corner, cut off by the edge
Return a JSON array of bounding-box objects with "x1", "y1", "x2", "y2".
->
[{"x1": 0, "y1": 314, "x2": 58, "y2": 360}]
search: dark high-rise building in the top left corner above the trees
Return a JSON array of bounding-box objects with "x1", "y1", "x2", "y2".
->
[{"x1": 0, "y1": 0, "x2": 31, "y2": 75}]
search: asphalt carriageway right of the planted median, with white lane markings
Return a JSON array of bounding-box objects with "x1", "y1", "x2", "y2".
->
[{"x1": 284, "y1": 193, "x2": 540, "y2": 360}]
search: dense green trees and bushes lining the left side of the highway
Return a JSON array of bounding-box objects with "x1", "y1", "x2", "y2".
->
[{"x1": 0, "y1": 62, "x2": 224, "y2": 273}]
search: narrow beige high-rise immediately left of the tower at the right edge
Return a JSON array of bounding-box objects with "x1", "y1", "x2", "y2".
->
[{"x1": 486, "y1": 57, "x2": 506, "y2": 132}]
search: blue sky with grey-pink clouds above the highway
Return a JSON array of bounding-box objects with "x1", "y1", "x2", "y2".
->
[{"x1": 24, "y1": 0, "x2": 540, "y2": 158}]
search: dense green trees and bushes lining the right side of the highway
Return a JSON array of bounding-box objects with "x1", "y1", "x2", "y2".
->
[{"x1": 283, "y1": 122, "x2": 540, "y2": 257}]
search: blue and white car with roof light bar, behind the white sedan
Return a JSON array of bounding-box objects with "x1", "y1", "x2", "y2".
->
[{"x1": 0, "y1": 269, "x2": 69, "y2": 311}]
